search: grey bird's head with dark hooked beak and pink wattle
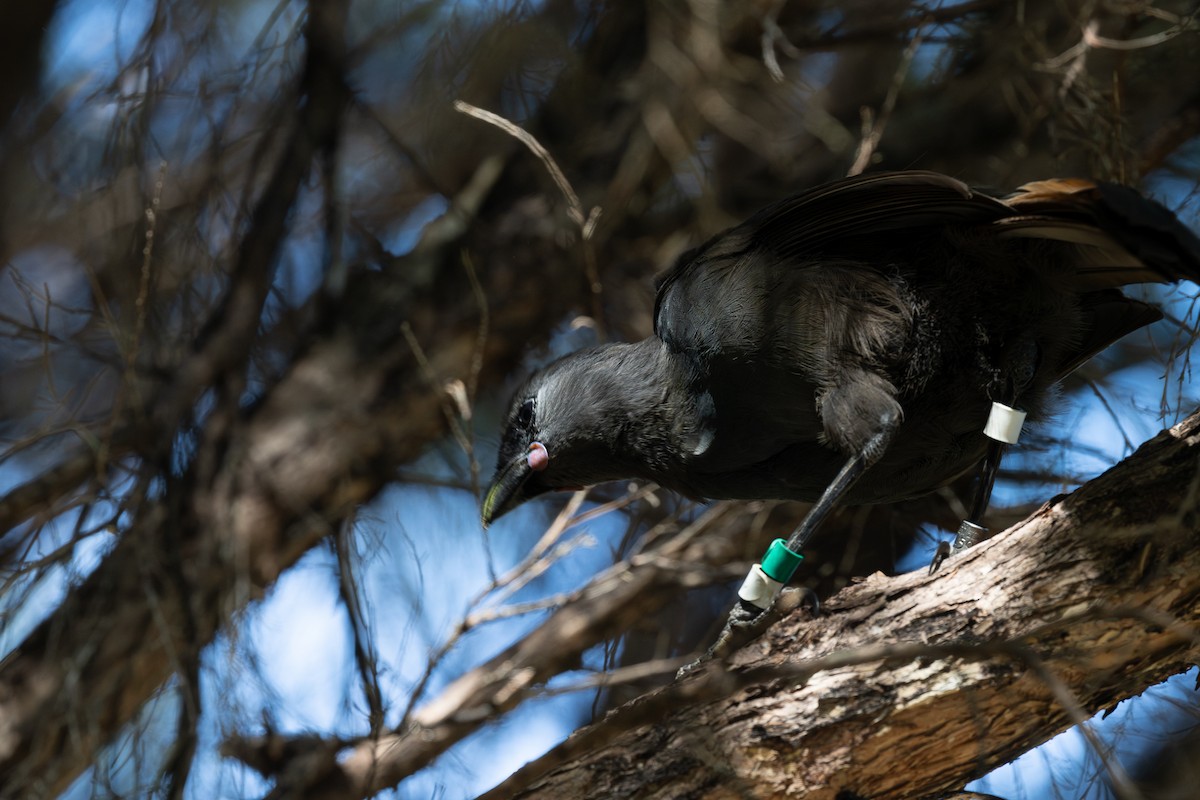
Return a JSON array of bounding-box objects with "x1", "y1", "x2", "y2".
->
[{"x1": 481, "y1": 344, "x2": 652, "y2": 525}]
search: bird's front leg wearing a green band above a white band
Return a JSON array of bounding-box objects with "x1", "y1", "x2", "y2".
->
[{"x1": 677, "y1": 405, "x2": 901, "y2": 678}]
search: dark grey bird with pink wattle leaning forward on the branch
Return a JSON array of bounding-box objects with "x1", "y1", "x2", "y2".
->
[{"x1": 482, "y1": 172, "x2": 1200, "y2": 551}]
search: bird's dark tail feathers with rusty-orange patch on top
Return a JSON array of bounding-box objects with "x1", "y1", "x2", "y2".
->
[{"x1": 992, "y1": 179, "x2": 1200, "y2": 291}]
